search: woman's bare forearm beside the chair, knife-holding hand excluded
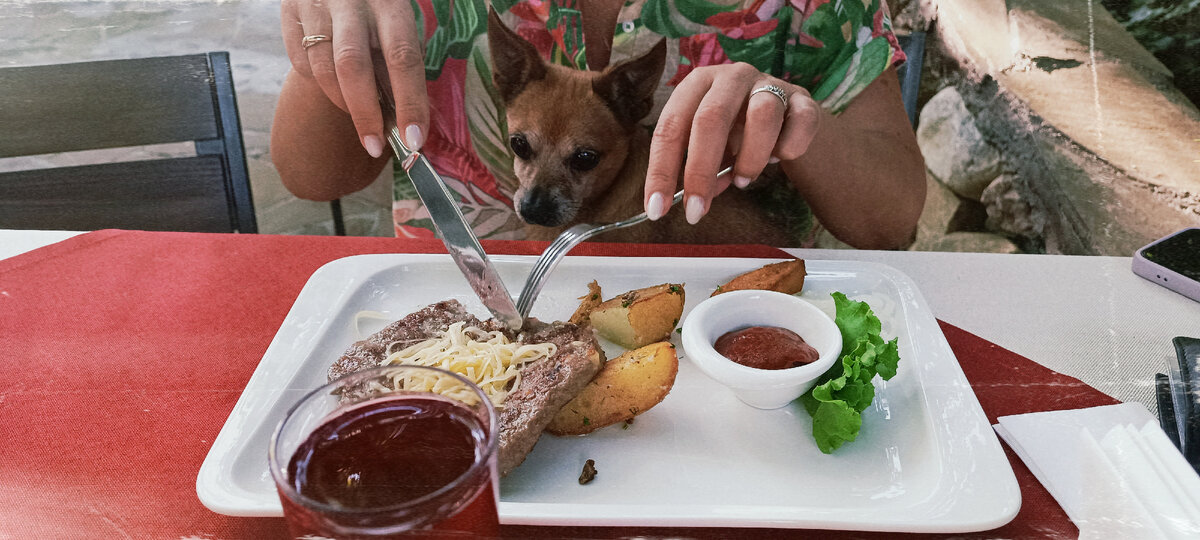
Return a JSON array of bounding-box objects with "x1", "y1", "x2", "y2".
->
[{"x1": 271, "y1": 71, "x2": 388, "y2": 200}]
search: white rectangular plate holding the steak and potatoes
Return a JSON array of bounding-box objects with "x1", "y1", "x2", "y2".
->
[{"x1": 197, "y1": 254, "x2": 1021, "y2": 533}]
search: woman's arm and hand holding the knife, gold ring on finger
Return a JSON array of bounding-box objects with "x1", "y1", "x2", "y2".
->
[{"x1": 271, "y1": 0, "x2": 428, "y2": 200}]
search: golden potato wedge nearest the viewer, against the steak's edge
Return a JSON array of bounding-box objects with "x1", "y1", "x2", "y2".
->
[{"x1": 546, "y1": 341, "x2": 679, "y2": 436}]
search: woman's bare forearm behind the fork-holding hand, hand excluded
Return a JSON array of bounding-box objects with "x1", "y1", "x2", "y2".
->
[{"x1": 780, "y1": 68, "x2": 925, "y2": 250}]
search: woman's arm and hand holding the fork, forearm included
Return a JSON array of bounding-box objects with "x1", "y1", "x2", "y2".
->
[{"x1": 644, "y1": 64, "x2": 925, "y2": 248}]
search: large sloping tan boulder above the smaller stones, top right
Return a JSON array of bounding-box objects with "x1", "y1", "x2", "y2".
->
[{"x1": 930, "y1": 0, "x2": 1200, "y2": 257}]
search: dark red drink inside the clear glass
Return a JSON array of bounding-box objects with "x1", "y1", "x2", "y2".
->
[{"x1": 281, "y1": 396, "x2": 499, "y2": 539}]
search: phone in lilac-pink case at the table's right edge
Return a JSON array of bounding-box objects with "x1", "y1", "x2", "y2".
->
[{"x1": 1133, "y1": 227, "x2": 1200, "y2": 301}]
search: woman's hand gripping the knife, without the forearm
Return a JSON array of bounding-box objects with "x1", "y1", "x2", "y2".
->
[{"x1": 281, "y1": 0, "x2": 430, "y2": 157}]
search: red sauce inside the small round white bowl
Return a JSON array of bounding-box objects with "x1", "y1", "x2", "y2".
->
[{"x1": 713, "y1": 326, "x2": 821, "y2": 370}]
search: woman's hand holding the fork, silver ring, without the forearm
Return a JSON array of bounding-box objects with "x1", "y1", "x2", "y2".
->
[{"x1": 644, "y1": 64, "x2": 824, "y2": 223}]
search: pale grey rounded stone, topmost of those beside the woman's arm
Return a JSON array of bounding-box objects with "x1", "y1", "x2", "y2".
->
[{"x1": 917, "y1": 86, "x2": 1000, "y2": 200}]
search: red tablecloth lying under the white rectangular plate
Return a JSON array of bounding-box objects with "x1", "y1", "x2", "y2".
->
[{"x1": 0, "y1": 230, "x2": 1115, "y2": 539}]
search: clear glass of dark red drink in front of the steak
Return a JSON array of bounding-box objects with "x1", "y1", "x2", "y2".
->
[{"x1": 268, "y1": 366, "x2": 499, "y2": 539}]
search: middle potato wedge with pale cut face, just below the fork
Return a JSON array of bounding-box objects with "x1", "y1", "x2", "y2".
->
[{"x1": 588, "y1": 283, "x2": 684, "y2": 349}]
